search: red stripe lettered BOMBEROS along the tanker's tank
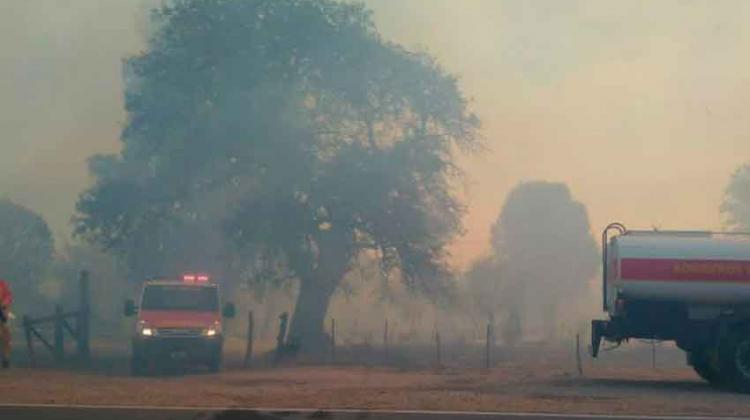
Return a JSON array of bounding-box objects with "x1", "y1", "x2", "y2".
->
[{"x1": 620, "y1": 258, "x2": 750, "y2": 282}]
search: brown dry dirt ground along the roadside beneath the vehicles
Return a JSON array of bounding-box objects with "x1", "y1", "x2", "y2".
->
[{"x1": 0, "y1": 345, "x2": 750, "y2": 416}]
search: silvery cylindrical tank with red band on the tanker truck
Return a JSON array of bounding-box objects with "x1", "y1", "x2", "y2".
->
[{"x1": 607, "y1": 231, "x2": 750, "y2": 312}]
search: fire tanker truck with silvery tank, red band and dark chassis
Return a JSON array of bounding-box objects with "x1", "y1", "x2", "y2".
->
[{"x1": 590, "y1": 223, "x2": 750, "y2": 392}]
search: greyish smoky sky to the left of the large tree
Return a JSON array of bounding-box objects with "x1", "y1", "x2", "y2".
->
[{"x1": 0, "y1": 0, "x2": 152, "y2": 236}]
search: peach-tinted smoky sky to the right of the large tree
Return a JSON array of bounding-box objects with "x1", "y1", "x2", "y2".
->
[{"x1": 368, "y1": 0, "x2": 750, "y2": 266}]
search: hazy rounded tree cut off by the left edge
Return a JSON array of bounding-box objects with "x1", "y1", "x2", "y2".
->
[{"x1": 0, "y1": 198, "x2": 54, "y2": 301}]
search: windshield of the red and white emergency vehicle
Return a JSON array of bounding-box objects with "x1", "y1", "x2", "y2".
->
[{"x1": 141, "y1": 285, "x2": 219, "y2": 311}]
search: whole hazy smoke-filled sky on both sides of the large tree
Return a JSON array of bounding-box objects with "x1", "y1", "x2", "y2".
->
[{"x1": 0, "y1": 0, "x2": 750, "y2": 264}]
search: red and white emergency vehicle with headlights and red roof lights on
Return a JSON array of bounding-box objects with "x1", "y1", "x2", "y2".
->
[{"x1": 125, "y1": 274, "x2": 235, "y2": 375}]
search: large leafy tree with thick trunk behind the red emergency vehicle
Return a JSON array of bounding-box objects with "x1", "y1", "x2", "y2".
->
[{"x1": 76, "y1": 0, "x2": 478, "y2": 350}]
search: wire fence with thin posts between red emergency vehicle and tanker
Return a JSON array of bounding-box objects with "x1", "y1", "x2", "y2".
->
[{"x1": 238, "y1": 313, "x2": 620, "y2": 376}]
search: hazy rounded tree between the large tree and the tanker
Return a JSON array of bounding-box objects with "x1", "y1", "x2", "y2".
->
[{"x1": 492, "y1": 181, "x2": 598, "y2": 337}]
